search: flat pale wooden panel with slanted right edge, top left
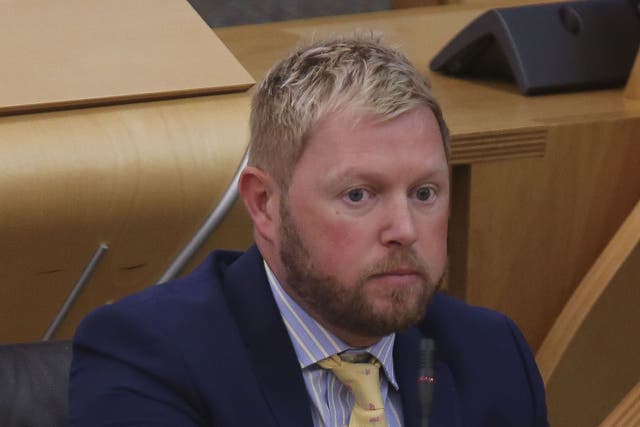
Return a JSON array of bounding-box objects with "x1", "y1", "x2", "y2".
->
[{"x1": 0, "y1": 0, "x2": 253, "y2": 114}]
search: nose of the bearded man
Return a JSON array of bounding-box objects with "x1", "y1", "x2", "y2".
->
[{"x1": 380, "y1": 197, "x2": 418, "y2": 246}]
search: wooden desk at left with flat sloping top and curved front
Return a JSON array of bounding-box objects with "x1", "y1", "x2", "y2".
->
[{"x1": 0, "y1": 0, "x2": 253, "y2": 342}]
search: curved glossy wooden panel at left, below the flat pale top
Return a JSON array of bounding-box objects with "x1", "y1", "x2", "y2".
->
[{"x1": 0, "y1": 94, "x2": 251, "y2": 342}]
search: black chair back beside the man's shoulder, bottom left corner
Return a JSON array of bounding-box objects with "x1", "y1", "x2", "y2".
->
[{"x1": 0, "y1": 341, "x2": 72, "y2": 427}]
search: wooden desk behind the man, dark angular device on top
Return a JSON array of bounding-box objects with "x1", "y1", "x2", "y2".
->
[{"x1": 217, "y1": 6, "x2": 640, "y2": 349}]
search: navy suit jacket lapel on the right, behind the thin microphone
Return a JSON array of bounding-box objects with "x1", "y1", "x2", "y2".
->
[{"x1": 393, "y1": 328, "x2": 462, "y2": 427}]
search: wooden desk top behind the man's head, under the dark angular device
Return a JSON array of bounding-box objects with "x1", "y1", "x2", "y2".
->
[{"x1": 216, "y1": 5, "x2": 640, "y2": 164}]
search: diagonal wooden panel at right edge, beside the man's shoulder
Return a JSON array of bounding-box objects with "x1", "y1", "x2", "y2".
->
[{"x1": 537, "y1": 201, "x2": 640, "y2": 427}]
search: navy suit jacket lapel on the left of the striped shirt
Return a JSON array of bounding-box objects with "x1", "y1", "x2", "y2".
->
[{"x1": 224, "y1": 247, "x2": 313, "y2": 427}]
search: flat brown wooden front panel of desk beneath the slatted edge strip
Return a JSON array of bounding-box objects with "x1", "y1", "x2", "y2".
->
[{"x1": 462, "y1": 119, "x2": 640, "y2": 352}]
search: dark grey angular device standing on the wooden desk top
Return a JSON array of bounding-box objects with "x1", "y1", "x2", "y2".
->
[{"x1": 430, "y1": 0, "x2": 640, "y2": 95}]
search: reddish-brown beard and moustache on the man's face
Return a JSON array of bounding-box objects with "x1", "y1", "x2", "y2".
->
[{"x1": 280, "y1": 200, "x2": 442, "y2": 338}]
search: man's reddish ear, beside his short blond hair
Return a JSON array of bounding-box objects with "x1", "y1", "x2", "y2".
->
[{"x1": 238, "y1": 166, "x2": 280, "y2": 243}]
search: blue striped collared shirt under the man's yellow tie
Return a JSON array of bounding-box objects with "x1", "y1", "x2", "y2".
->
[{"x1": 264, "y1": 262, "x2": 402, "y2": 427}]
